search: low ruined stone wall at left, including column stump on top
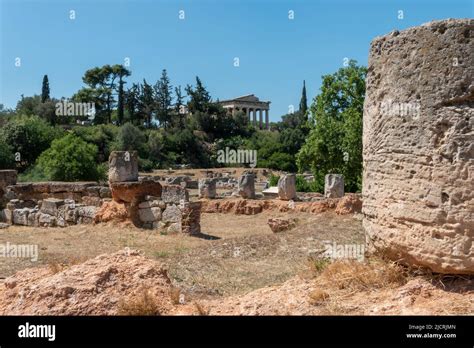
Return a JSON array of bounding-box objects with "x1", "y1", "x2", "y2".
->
[{"x1": 0, "y1": 151, "x2": 201, "y2": 235}]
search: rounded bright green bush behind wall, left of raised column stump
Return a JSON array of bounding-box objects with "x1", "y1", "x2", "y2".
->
[{"x1": 38, "y1": 134, "x2": 105, "y2": 181}]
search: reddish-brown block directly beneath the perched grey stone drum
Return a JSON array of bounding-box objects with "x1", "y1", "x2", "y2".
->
[{"x1": 110, "y1": 180, "x2": 162, "y2": 203}]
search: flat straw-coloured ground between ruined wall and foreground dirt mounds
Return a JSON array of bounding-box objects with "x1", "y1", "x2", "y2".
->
[{"x1": 0, "y1": 212, "x2": 364, "y2": 295}]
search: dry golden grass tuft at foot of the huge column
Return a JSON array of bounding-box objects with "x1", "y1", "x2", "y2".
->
[{"x1": 317, "y1": 259, "x2": 410, "y2": 291}]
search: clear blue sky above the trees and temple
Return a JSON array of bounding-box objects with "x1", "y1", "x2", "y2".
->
[{"x1": 0, "y1": 0, "x2": 474, "y2": 121}]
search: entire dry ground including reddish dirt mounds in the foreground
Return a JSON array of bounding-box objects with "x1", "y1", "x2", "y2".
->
[{"x1": 0, "y1": 211, "x2": 474, "y2": 315}]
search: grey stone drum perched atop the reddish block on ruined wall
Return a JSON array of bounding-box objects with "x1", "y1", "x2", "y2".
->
[{"x1": 109, "y1": 151, "x2": 138, "y2": 183}]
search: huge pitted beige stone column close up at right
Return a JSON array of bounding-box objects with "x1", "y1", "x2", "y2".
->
[{"x1": 363, "y1": 19, "x2": 474, "y2": 274}]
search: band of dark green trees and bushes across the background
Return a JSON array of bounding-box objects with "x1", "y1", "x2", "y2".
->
[{"x1": 0, "y1": 61, "x2": 366, "y2": 191}]
